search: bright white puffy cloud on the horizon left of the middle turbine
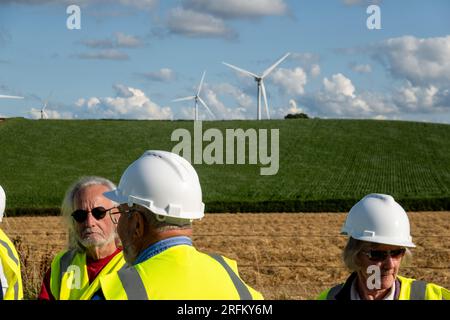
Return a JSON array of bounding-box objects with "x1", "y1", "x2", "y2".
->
[{"x1": 74, "y1": 85, "x2": 173, "y2": 120}]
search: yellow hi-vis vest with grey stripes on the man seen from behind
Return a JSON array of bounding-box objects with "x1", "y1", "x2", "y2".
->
[{"x1": 96, "y1": 245, "x2": 263, "y2": 300}]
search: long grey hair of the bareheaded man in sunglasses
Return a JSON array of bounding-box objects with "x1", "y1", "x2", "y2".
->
[{"x1": 61, "y1": 176, "x2": 118, "y2": 252}]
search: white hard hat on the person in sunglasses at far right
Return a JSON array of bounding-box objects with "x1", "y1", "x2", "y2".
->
[{"x1": 341, "y1": 193, "x2": 415, "y2": 248}]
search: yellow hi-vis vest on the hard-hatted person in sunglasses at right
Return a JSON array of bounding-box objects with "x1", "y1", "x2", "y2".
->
[{"x1": 317, "y1": 276, "x2": 450, "y2": 300}]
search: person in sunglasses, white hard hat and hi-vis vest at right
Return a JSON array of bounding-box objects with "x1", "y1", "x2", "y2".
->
[{"x1": 318, "y1": 194, "x2": 450, "y2": 300}]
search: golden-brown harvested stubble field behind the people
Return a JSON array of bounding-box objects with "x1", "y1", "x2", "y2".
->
[{"x1": 1, "y1": 212, "x2": 450, "y2": 299}]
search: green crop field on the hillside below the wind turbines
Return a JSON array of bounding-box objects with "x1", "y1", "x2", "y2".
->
[{"x1": 0, "y1": 118, "x2": 450, "y2": 215}]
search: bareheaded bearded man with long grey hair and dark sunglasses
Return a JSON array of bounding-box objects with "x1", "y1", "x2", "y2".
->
[{"x1": 38, "y1": 177, "x2": 125, "y2": 300}]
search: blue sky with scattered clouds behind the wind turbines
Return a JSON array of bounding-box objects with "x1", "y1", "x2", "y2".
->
[{"x1": 0, "y1": 0, "x2": 450, "y2": 123}]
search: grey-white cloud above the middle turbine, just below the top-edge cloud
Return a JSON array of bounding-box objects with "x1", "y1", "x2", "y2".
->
[{"x1": 167, "y1": 7, "x2": 236, "y2": 39}]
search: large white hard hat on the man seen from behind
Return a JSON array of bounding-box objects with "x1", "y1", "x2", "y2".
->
[{"x1": 104, "y1": 150, "x2": 205, "y2": 219}]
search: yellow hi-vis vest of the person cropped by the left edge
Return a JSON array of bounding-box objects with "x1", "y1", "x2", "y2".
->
[{"x1": 0, "y1": 229, "x2": 23, "y2": 300}]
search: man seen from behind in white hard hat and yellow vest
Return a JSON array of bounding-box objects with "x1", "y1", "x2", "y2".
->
[{"x1": 88, "y1": 151, "x2": 263, "y2": 300}]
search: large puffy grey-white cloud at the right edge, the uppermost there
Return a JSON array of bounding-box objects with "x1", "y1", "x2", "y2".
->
[{"x1": 374, "y1": 35, "x2": 450, "y2": 87}]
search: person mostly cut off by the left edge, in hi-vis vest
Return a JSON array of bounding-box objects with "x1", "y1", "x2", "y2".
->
[{"x1": 0, "y1": 186, "x2": 23, "y2": 300}]
